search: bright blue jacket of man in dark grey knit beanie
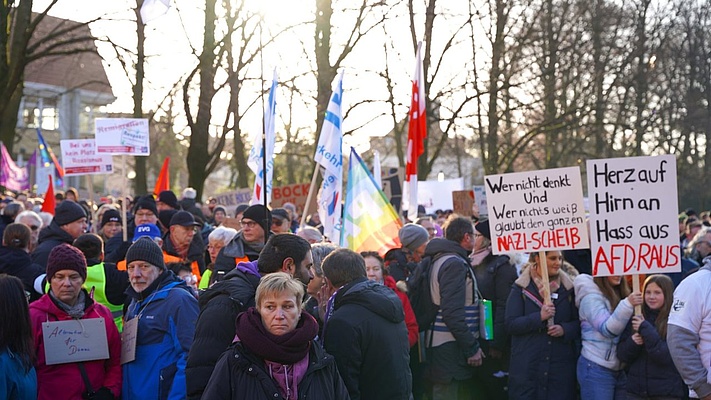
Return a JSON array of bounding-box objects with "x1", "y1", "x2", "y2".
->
[{"x1": 123, "y1": 271, "x2": 198, "y2": 400}]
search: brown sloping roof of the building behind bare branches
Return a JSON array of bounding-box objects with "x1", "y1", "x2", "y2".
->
[{"x1": 25, "y1": 14, "x2": 113, "y2": 96}]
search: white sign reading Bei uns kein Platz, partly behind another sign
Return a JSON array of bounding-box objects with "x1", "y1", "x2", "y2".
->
[{"x1": 59, "y1": 139, "x2": 114, "y2": 176}]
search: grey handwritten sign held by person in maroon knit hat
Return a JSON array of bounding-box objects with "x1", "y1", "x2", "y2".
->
[{"x1": 42, "y1": 318, "x2": 109, "y2": 365}]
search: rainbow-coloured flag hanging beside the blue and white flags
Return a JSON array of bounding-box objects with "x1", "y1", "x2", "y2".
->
[{"x1": 341, "y1": 147, "x2": 402, "y2": 255}]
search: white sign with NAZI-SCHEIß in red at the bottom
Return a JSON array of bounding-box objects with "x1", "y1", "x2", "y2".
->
[{"x1": 484, "y1": 167, "x2": 588, "y2": 254}]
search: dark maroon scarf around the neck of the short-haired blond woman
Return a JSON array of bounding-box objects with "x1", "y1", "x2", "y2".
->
[{"x1": 235, "y1": 307, "x2": 318, "y2": 365}]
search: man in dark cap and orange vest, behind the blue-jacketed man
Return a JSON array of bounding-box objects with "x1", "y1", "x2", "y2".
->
[{"x1": 162, "y1": 211, "x2": 205, "y2": 283}]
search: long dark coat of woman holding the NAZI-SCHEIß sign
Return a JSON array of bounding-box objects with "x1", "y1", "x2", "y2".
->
[{"x1": 505, "y1": 269, "x2": 580, "y2": 400}]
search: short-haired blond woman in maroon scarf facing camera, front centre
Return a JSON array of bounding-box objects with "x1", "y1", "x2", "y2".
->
[{"x1": 203, "y1": 272, "x2": 349, "y2": 400}]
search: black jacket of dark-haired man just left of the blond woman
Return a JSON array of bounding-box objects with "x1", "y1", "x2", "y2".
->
[{"x1": 185, "y1": 269, "x2": 259, "y2": 399}]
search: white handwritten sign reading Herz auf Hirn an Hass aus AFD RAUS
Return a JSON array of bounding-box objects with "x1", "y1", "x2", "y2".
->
[{"x1": 587, "y1": 155, "x2": 681, "y2": 276}]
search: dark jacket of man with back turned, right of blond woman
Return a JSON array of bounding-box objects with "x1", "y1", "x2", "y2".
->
[{"x1": 323, "y1": 278, "x2": 412, "y2": 400}]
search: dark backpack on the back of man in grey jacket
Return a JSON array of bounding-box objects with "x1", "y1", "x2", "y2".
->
[{"x1": 407, "y1": 255, "x2": 455, "y2": 332}]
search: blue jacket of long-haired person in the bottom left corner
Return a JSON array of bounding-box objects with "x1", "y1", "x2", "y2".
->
[{"x1": 0, "y1": 348, "x2": 37, "y2": 400}]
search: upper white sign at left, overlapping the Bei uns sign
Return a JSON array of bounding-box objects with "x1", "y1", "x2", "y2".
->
[{"x1": 95, "y1": 118, "x2": 150, "y2": 156}]
